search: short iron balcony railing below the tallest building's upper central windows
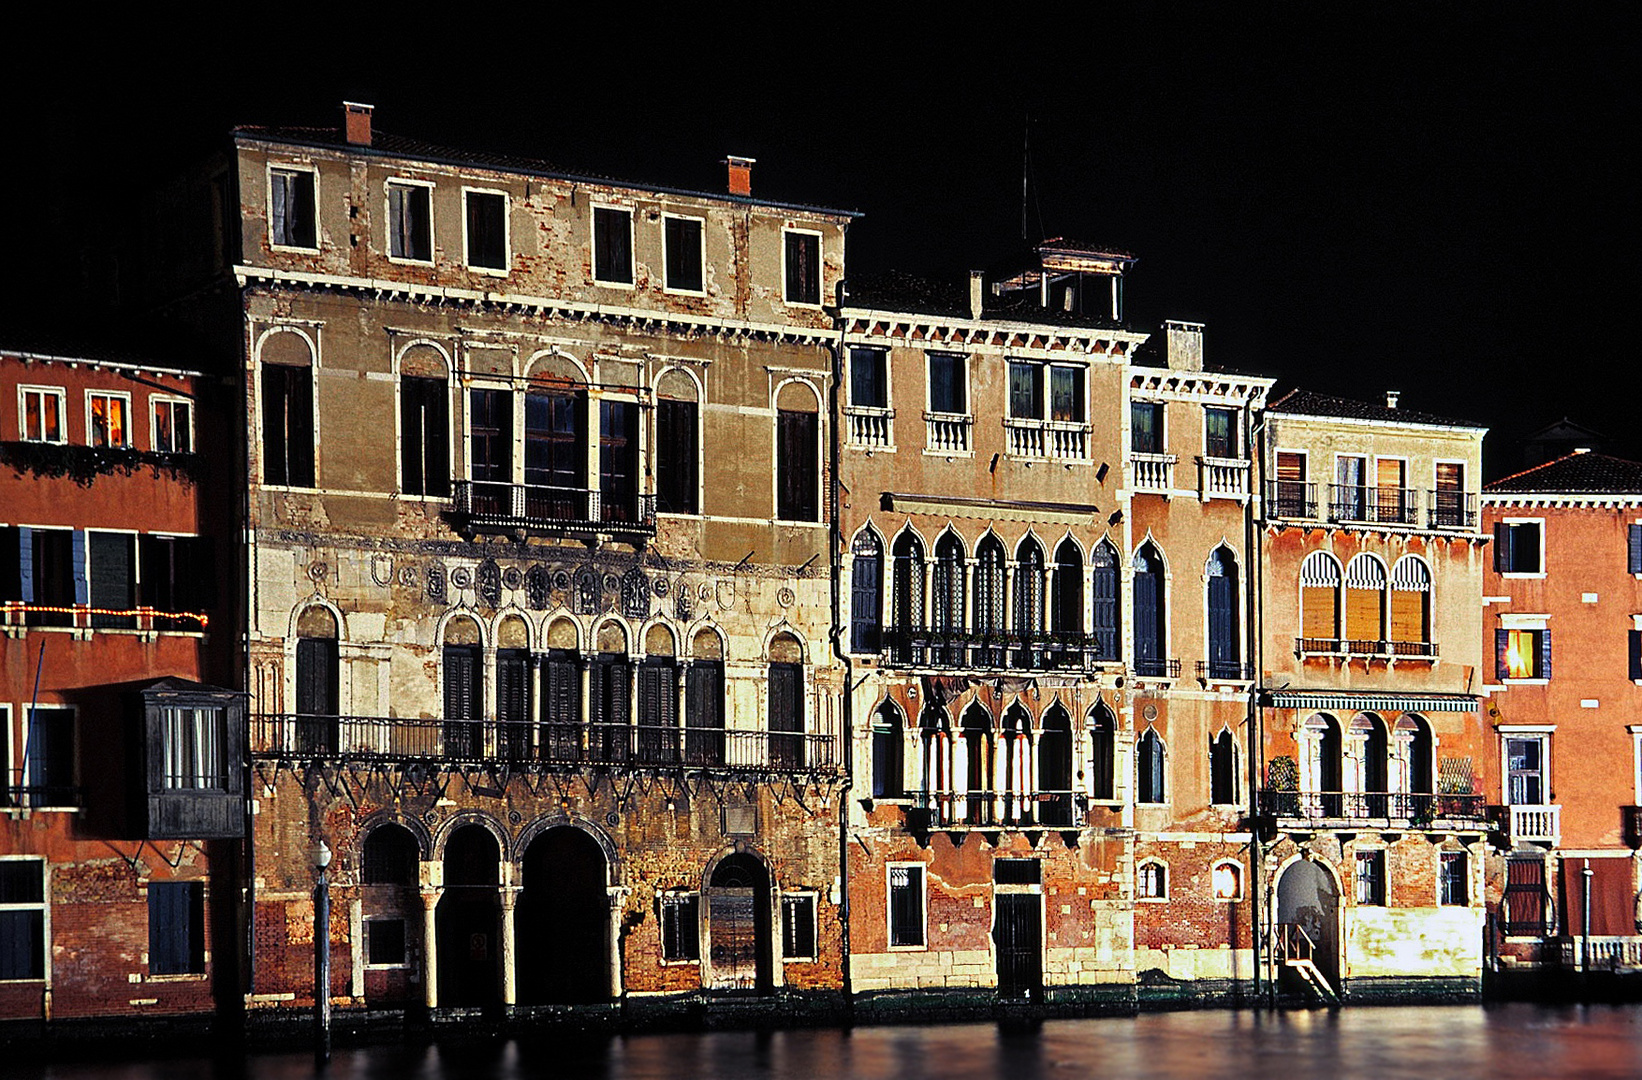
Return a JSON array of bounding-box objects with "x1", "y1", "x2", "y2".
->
[{"x1": 450, "y1": 479, "x2": 655, "y2": 537}]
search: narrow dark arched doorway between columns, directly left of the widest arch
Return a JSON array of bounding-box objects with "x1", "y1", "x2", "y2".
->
[{"x1": 433, "y1": 826, "x2": 501, "y2": 1006}]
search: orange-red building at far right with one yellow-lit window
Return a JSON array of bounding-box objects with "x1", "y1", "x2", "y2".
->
[{"x1": 1483, "y1": 451, "x2": 1642, "y2": 968}]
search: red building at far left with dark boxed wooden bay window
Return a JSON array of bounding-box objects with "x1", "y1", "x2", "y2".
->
[{"x1": 0, "y1": 341, "x2": 245, "y2": 1029}]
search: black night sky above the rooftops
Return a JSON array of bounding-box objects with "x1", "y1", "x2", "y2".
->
[{"x1": 9, "y1": 2, "x2": 1642, "y2": 474}]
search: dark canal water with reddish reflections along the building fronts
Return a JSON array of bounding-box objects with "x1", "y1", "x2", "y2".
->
[{"x1": 12, "y1": 1004, "x2": 1642, "y2": 1080}]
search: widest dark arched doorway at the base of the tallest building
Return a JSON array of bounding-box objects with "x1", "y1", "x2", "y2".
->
[{"x1": 514, "y1": 826, "x2": 611, "y2": 1004}]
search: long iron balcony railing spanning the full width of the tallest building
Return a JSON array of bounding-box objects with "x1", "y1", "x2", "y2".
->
[{"x1": 251, "y1": 712, "x2": 839, "y2": 771}]
